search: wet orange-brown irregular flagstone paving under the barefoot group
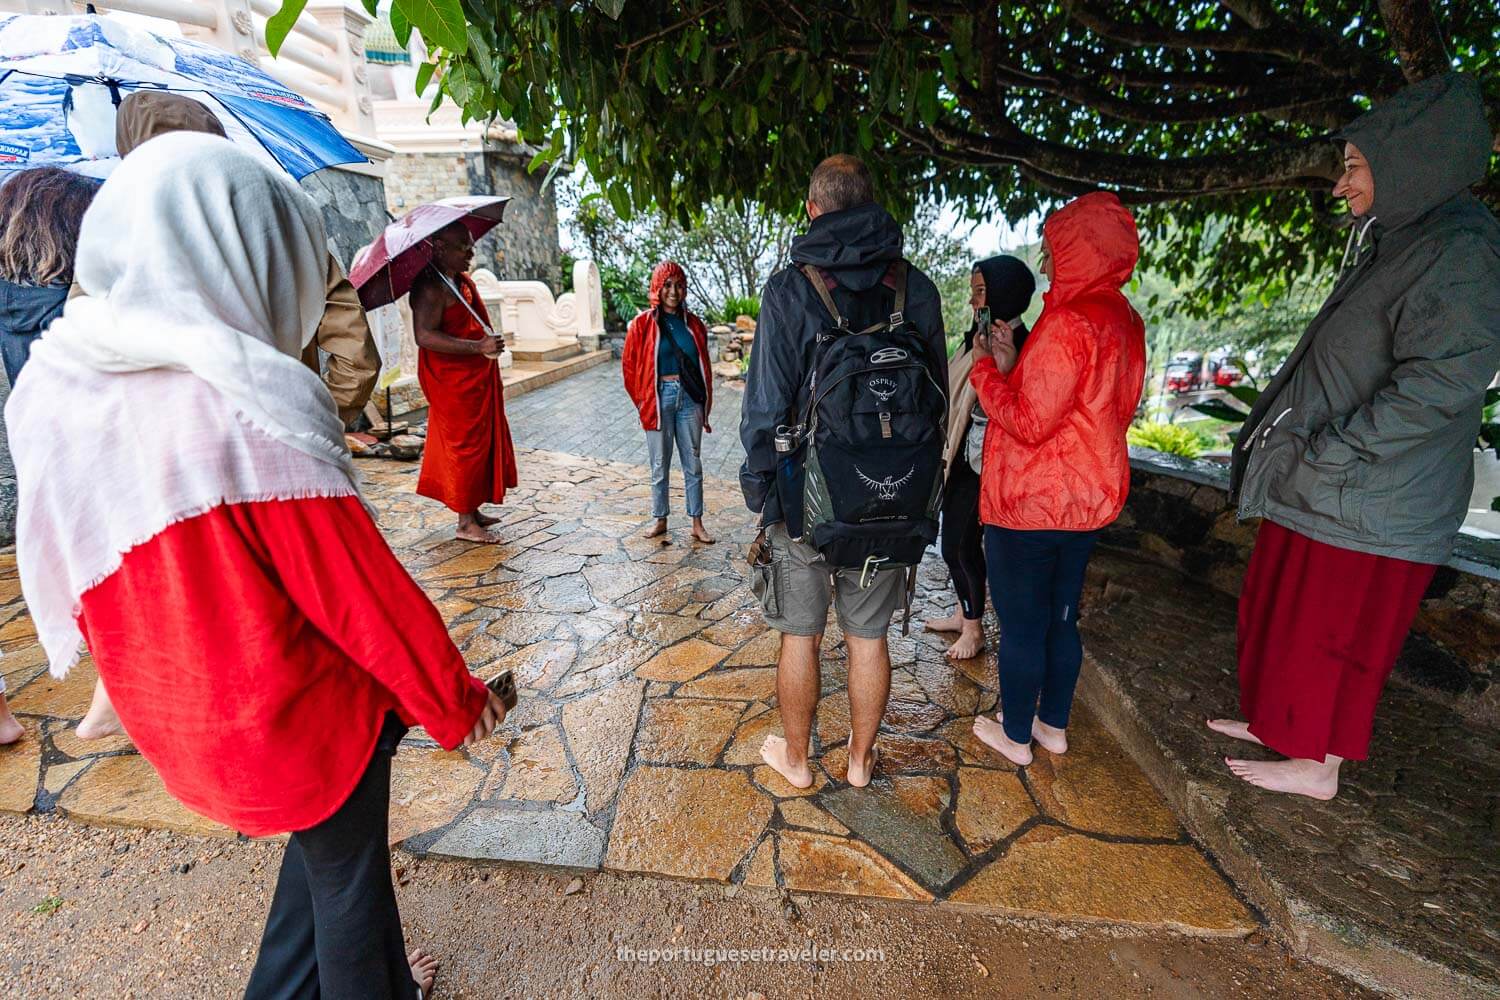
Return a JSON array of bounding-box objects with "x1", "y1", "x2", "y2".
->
[{"x1": 0, "y1": 450, "x2": 1257, "y2": 934}]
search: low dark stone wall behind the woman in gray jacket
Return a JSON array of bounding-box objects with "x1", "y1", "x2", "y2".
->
[{"x1": 1103, "y1": 448, "x2": 1500, "y2": 720}]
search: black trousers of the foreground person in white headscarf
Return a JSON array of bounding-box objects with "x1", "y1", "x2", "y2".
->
[{"x1": 245, "y1": 715, "x2": 417, "y2": 1000}]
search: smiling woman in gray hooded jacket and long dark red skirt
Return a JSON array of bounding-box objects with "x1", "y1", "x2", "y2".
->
[{"x1": 1209, "y1": 73, "x2": 1500, "y2": 799}]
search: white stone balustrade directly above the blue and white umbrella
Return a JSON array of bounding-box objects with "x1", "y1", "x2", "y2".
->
[{"x1": 0, "y1": 0, "x2": 375, "y2": 144}]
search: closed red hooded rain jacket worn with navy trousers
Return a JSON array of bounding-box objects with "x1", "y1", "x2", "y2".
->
[{"x1": 969, "y1": 192, "x2": 1146, "y2": 531}]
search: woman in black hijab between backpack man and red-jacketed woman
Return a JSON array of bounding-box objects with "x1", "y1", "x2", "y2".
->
[{"x1": 926, "y1": 255, "x2": 1037, "y2": 660}]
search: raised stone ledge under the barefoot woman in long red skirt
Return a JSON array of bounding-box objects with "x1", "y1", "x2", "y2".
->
[{"x1": 1079, "y1": 546, "x2": 1500, "y2": 1000}]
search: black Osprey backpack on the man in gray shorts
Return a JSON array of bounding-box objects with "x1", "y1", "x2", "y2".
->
[{"x1": 795, "y1": 261, "x2": 948, "y2": 574}]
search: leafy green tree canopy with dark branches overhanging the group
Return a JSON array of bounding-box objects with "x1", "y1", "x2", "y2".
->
[{"x1": 405, "y1": 0, "x2": 1500, "y2": 319}]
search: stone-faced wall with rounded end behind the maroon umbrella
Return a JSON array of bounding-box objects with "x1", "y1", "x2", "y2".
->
[{"x1": 386, "y1": 144, "x2": 563, "y2": 291}]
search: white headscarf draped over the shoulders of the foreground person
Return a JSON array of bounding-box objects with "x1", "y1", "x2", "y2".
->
[{"x1": 5, "y1": 132, "x2": 359, "y2": 676}]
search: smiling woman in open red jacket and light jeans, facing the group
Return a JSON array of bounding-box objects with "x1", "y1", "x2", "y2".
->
[{"x1": 621, "y1": 261, "x2": 714, "y2": 544}]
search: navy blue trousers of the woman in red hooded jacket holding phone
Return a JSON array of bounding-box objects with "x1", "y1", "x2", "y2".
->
[{"x1": 984, "y1": 525, "x2": 1098, "y2": 744}]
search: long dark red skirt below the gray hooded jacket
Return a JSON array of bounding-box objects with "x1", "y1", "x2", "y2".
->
[{"x1": 1239, "y1": 520, "x2": 1437, "y2": 760}]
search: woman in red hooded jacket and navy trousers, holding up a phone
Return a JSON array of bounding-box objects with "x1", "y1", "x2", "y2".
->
[{"x1": 969, "y1": 192, "x2": 1146, "y2": 766}]
